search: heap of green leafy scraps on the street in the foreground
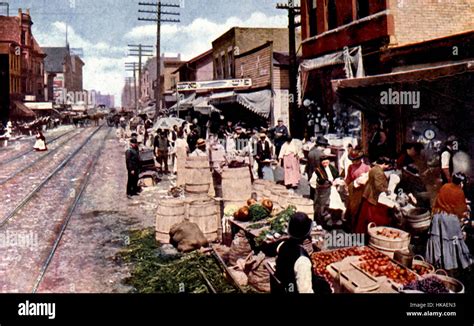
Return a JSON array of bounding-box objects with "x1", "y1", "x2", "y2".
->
[{"x1": 116, "y1": 228, "x2": 239, "y2": 293}]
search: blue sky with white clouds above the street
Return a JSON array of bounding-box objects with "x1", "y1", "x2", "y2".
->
[{"x1": 5, "y1": 0, "x2": 288, "y2": 103}]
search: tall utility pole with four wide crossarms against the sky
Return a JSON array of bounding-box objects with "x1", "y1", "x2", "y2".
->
[{"x1": 138, "y1": 0, "x2": 181, "y2": 116}]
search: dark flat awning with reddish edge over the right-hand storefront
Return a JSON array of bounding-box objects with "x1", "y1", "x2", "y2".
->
[{"x1": 332, "y1": 60, "x2": 474, "y2": 121}]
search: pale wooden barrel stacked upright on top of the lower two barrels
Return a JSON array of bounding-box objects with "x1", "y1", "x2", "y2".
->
[{"x1": 184, "y1": 157, "x2": 212, "y2": 198}]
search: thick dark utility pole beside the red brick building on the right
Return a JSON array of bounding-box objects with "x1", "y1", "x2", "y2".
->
[{"x1": 277, "y1": 0, "x2": 304, "y2": 138}]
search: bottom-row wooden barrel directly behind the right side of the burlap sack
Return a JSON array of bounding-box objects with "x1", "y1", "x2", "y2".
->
[{"x1": 188, "y1": 200, "x2": 220, "y2": 242}]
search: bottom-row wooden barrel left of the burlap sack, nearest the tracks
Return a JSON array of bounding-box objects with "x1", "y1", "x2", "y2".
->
[{"x1": 155, "y1": 199, "x2": 186, "y2": 243}]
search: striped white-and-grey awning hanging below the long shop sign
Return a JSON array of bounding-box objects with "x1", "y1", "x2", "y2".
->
[{"x1": 209, "y1": 89, "x2": 272, "y2": 119}]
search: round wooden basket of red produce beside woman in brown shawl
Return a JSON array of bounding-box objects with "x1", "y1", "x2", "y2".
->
[{"x1": 368, "y1": 223, "x2": 411, "y2": 258}]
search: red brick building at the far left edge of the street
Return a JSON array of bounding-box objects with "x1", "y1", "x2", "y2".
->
[{"x1": 0, "y1": 9, "x2": 46, "y2": 122}]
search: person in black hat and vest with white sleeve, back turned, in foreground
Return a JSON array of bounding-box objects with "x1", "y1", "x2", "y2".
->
[{"x1": 271, "y1": 212, "x2": 331, "y2": 294}]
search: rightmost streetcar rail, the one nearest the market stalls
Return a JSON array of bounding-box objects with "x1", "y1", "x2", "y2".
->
[{"x1": 31, "y1": 129, "x2": 111, "y2": 293}]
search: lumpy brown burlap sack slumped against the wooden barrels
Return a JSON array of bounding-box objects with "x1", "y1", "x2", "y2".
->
[{"x1": 170, "y1": 221, "x2": 209, "y2": 252}]
